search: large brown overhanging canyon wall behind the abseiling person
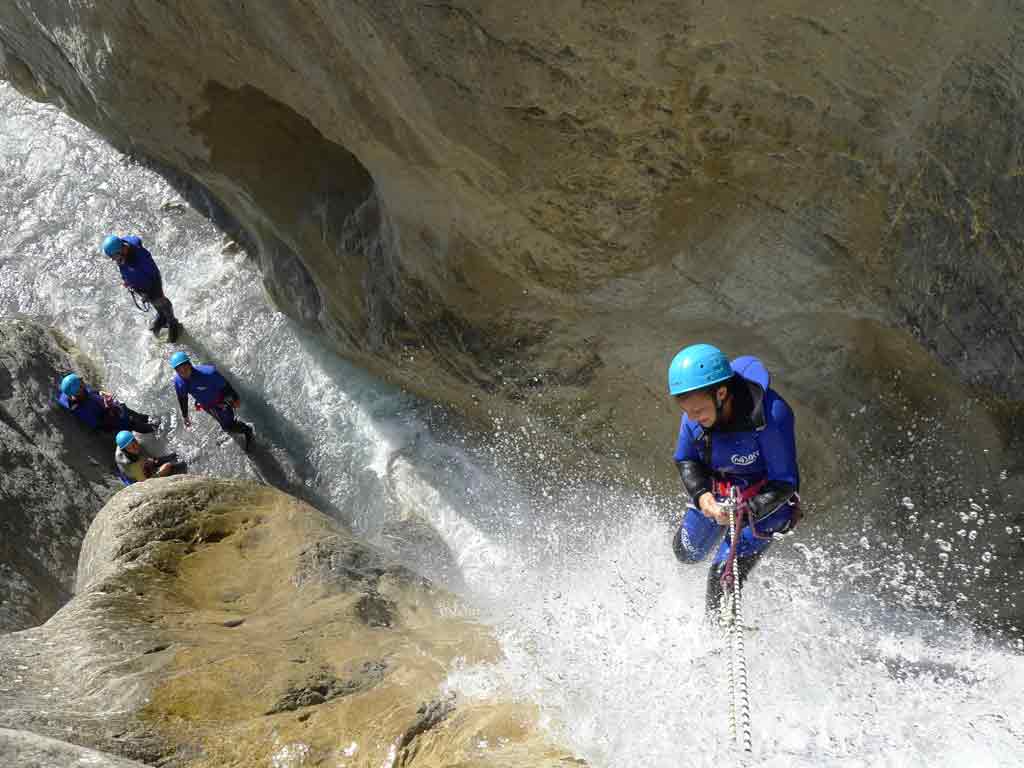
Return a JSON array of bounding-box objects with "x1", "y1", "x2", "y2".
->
[{"x1": 0, "y1": 6, "x2": 1024, "y2": 615}]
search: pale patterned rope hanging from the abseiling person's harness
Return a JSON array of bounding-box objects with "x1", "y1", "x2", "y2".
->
[{"x1": 722, "y1": 486, "x2": 763, "y2": 755}]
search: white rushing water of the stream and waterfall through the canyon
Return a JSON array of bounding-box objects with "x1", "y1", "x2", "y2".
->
[{"x1": 0, "y1": 85, "x2": 1024, "y2": 768}]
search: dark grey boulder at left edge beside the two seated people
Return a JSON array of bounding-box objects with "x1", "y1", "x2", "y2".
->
[{"x1": 0, "y1": 321, "x2": 121, "y2": 632}]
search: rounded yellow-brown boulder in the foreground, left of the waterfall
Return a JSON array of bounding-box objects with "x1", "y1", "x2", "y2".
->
[{"x1": 0, "y1": 476, "x2": 582, "y2": 767}]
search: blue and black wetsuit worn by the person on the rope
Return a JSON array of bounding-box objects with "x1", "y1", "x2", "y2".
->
[{"x1": 673, "y1": 356, "x2": 800, "y2": 608}]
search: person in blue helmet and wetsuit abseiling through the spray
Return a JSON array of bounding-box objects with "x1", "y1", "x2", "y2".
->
[{"x1": 669, "y1": 344, "x2": 800, "y2": 612}]
